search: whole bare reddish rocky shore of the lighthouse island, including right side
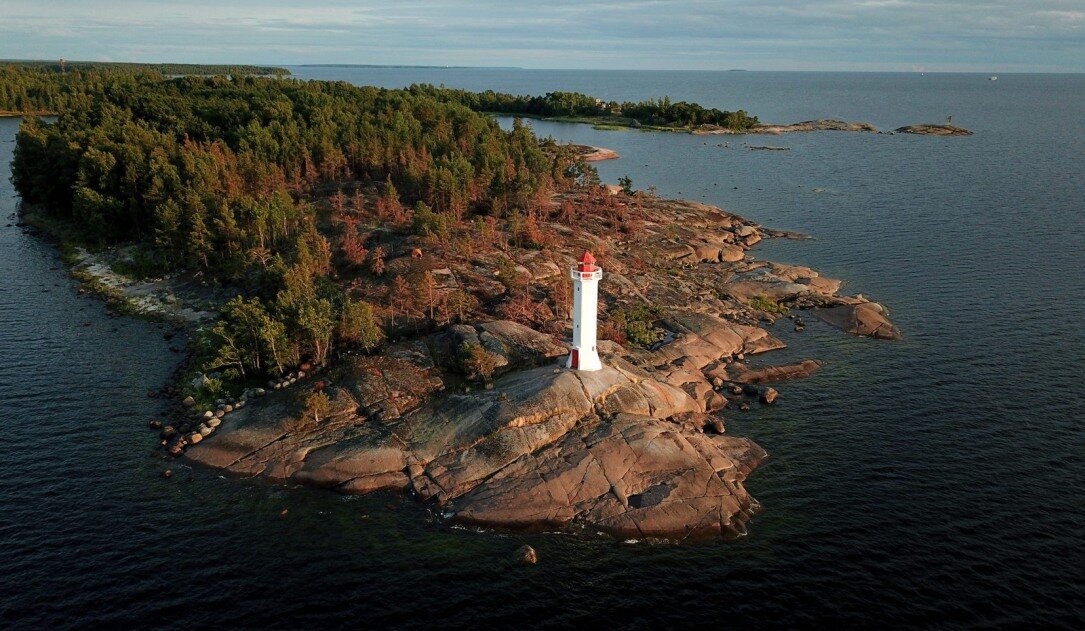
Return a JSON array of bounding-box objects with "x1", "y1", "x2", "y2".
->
[{"x1": 161, "y1": 193, "x2": 899, "y2": 540}]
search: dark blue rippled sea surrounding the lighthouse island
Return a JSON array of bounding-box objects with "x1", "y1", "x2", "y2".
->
[{"x1": 0, "y1": 67, "x2": 1085, "y2": 629}]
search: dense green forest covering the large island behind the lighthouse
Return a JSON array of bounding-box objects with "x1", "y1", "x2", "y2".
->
[{"x1": 0, "y1": 67, "x2": 591, "y2": 388}]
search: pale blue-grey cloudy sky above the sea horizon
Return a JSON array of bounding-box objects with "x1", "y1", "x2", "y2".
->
[{"x1": 0, "y1": 0, "x2": 1085, "y2": 73}]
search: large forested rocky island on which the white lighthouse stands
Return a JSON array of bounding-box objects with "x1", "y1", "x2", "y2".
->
[{"x1": 0, "y1": 64, "x2": 899, "y2": 539}]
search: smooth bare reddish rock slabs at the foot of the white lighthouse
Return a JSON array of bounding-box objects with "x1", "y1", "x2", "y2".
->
[{"x1": 187, "y1": 316, "x2": 767, "y2": 539}]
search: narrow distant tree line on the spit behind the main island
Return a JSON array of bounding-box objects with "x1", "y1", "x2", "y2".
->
[{"x1": 409, "y1": 85, "x2": 758, "y2": 130}]
